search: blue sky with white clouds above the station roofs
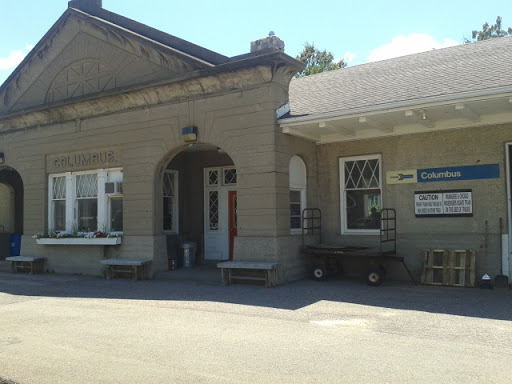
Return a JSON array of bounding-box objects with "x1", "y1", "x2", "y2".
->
[{"x1": 0, "y1": 0, "x2": 512, "y2": 84}]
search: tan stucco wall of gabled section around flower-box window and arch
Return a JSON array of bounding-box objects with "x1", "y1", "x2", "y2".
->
[{"x1": 0, "y1": 67, "x2": 296, "y2": 273}]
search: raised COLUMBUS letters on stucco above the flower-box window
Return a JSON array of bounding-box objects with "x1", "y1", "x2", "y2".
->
[{"x1": 46, "y1": 148, "x2": 122, "y2": 173}]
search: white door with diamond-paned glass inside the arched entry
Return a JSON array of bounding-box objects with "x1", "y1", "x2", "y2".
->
[{"x1": 204, "y1": 167, "x2": 236, "y2": 260}]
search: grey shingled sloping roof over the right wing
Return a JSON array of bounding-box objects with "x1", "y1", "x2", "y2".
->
[{"x1": 289, "y1": 37, "x2": 512, "y2": 117}]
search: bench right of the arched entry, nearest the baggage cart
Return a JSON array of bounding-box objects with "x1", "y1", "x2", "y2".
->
[{"x1": 217, "y1": 261, "x2": 279, "y2": 288}]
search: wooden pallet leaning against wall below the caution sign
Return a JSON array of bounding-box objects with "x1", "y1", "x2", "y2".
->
[{"x1": 421, "y1": 249, "x2": 476, "y2": 287}]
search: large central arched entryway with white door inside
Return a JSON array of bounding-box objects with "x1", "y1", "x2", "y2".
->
[{"x1": 157, "y1": 143, "x2": 237, "y2": 264}]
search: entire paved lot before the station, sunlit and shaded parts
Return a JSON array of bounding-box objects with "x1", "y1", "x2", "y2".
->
[{"x1": 0, "y1": 272, "x2": 512, "y2": 384}]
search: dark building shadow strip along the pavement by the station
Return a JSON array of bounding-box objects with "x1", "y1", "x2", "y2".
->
[{"x1": 0, "y1": 266, "x2": 512, "y2": 321}]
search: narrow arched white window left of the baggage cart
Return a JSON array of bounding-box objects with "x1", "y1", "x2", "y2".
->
[{"x1": 289, "y1": 156, "x2": 307, "y2": 234}]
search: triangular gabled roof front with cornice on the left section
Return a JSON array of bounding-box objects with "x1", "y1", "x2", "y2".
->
[{"x1": 0, "y1": 0, "x2": 302, "y2": 130}]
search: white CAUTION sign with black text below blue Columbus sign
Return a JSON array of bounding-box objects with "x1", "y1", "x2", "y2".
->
[{"x1": 414, "y1": 189, "x2": 473, "y2": 217}]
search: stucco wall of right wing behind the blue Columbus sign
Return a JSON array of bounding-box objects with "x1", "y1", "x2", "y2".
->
[{"x1": 318, "y1": 125, "x2": 512, "y2": 277}]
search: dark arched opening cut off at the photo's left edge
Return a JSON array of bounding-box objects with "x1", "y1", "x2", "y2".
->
[{"x1": 0, "y1": 167, "x2": 23, "y2": 259}]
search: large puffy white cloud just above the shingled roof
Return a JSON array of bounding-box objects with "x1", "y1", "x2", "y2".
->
[{"x1": 368, "y1": 33, "x2": 459, "y2": 62}]
